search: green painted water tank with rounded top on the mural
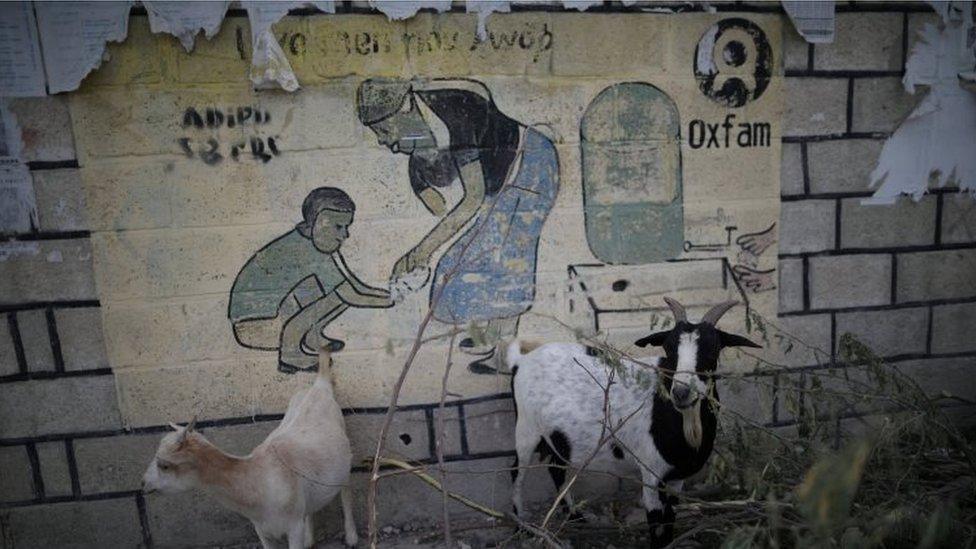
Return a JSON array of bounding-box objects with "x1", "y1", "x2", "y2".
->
[{"x1": 580, "y1": 82, "x2": 684, "y2": 265}]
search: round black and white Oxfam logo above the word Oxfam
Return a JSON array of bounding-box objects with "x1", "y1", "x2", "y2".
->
[{"x1": 695, "y1": 17, "x2": 773, "y2": 107}]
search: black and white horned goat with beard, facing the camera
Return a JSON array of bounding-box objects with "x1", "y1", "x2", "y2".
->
[{"x1": 506, "y1": 298, "x2": 759, "y2": 547}]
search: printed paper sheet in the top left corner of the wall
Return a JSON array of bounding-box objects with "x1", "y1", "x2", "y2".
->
[{"x1": 0, "y1": 2, "x2": 45, "y2": 97}]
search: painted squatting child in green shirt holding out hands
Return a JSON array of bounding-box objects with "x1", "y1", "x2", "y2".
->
[{"x1": 228, "y1": 187, "x2": 393, "y2": 373}]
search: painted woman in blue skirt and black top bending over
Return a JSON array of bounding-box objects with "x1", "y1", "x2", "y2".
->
[{"x1": 357, "y1": 79, "x2": 559, "y2": 372}]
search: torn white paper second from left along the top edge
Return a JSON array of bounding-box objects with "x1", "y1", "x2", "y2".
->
[{"x1": 34, "y1": 2, "x2": 132, "y2": 93}]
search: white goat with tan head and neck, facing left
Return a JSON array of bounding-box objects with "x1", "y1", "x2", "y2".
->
[{"x1": 142, "y1": 350, "x2": 357, "y2": 549}]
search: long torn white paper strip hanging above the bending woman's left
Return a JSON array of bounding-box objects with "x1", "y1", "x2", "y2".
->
[{"x1": 241, "y1": 0, "x2": 335, "y2": 91}]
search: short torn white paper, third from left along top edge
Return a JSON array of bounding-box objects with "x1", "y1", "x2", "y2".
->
[{"x1": 142, "y1": 0, "x2": 230, "y2": 52}]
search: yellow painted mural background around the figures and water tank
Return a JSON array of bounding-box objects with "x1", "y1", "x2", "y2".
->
[{"x1": 71, "y1": 14, "x2": 783, "y2": 426}]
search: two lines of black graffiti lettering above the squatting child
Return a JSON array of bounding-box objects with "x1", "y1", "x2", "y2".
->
[{"x1": 176, "y1": 107, "x2": 281, "y2": 166}]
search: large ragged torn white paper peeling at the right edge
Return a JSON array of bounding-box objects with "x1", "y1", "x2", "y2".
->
[{"x1": 863, "y1": 5, "x2": 976, "y2": 204}]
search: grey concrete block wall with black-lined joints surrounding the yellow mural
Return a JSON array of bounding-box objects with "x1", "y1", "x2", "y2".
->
[{"x1": 0, "y1": 5, "x2": 976, "y2": 547}]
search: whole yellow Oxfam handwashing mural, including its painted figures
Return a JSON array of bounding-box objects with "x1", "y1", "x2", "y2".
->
[{"x1": 71, "y1": 13, "x2": 782, "y2": 426}]
